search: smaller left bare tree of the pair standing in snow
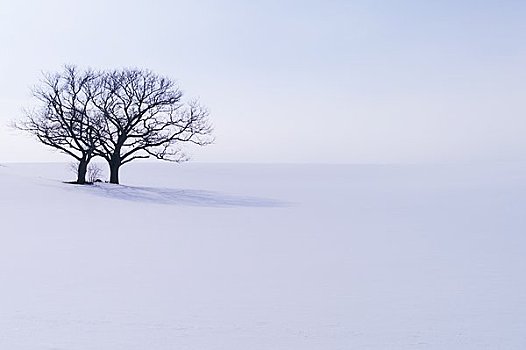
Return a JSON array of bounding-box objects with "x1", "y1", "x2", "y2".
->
[{"x1": 15, "y1": 66, "x2": 100, "y2": 184}]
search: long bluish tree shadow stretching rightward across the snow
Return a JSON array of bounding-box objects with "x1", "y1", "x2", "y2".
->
[{"x1": 79, "y1": 183, "x2": 290, "y2": 208}]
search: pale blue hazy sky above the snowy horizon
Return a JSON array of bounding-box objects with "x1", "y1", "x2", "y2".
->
[{"x1": 0, "y1": 0, "x2": 526, "y2": 163}]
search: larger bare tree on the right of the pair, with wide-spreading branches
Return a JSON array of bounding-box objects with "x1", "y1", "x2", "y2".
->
[{"x1": 93, "y1": 69, "x2": 212, "y2": 184}]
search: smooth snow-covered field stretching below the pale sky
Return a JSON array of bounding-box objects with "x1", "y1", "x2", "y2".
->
[{"x1": 0, "y1": 163, "x2": 526, "y2": 350}]
